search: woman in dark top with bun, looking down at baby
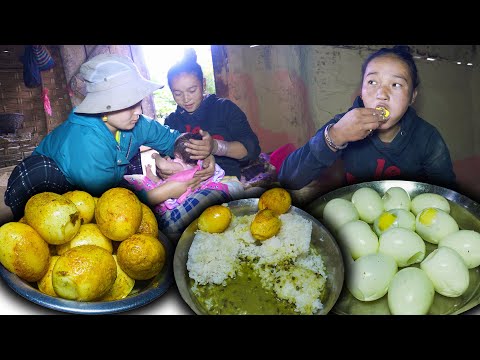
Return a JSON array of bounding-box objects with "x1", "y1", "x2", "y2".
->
[{"x1": 161, "y1": 49, "x2": 261, "y2": 179}]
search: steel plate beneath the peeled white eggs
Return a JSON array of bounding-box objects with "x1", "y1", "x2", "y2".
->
[{"x1": 306, "y1": 180, "x2": 480, "y2": 315}]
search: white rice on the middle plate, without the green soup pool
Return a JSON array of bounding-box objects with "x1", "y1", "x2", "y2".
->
[{"x1": 187, "y1": 214, "x2": 327, "y2": 314}]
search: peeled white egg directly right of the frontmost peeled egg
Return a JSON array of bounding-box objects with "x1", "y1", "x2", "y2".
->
[{"x1": 420, "y1": 246, "x2": 470, "y2": 297}]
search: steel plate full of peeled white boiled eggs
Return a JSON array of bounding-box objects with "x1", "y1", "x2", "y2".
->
[{"x1": 306, "y1": 180, "x2": 480, "y2": 315}]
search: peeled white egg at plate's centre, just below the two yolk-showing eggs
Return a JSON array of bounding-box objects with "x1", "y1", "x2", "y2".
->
[{"x1": 378, "y1": 228, "x2": 425, "y2": 267}]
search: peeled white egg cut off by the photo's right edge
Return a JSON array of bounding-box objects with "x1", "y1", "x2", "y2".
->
[{"x1": 438, "y1": 230, "x2": 480, "y2": 269}]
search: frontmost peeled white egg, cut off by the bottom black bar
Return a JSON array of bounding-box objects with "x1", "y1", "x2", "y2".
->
[{"x1": 388, "y1": 267, "x2": 435, "y2": 315}]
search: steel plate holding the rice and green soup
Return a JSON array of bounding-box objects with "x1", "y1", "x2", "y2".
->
[{"x1": 173, "y1": 198, "x2": 344, "y2": 315}]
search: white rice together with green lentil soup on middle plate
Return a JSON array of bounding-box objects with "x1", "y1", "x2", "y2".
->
[{"x1": 187, "y1": 213, "x2": 327, "y2": 315}]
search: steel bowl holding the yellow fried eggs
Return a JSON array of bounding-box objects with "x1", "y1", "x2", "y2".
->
[{"x1": 0, "y1": 232, "x2": 174, "y2": 314}]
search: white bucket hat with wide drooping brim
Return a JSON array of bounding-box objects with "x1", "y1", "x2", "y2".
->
[{"x1": 75, "y1": 54, "x2": 164, "y2": 114}]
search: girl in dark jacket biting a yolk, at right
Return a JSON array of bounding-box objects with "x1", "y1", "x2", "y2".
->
[{"x1": 279, "y1": 46, "x2": 456, "y2": 189}]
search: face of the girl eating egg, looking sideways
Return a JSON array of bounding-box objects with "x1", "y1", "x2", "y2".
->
[{"x1": 361, "y1": 55, "x2": 417, "y2": 130}]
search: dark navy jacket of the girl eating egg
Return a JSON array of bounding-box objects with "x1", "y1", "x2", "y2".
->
[{"x1": 279, "y1": 97, "x2": 456, "y2": 189}]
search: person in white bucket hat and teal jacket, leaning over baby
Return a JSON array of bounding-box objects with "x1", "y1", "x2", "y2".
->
[{"x1": 5, "y1": 54, "x2": 215, "y2": 221}]
